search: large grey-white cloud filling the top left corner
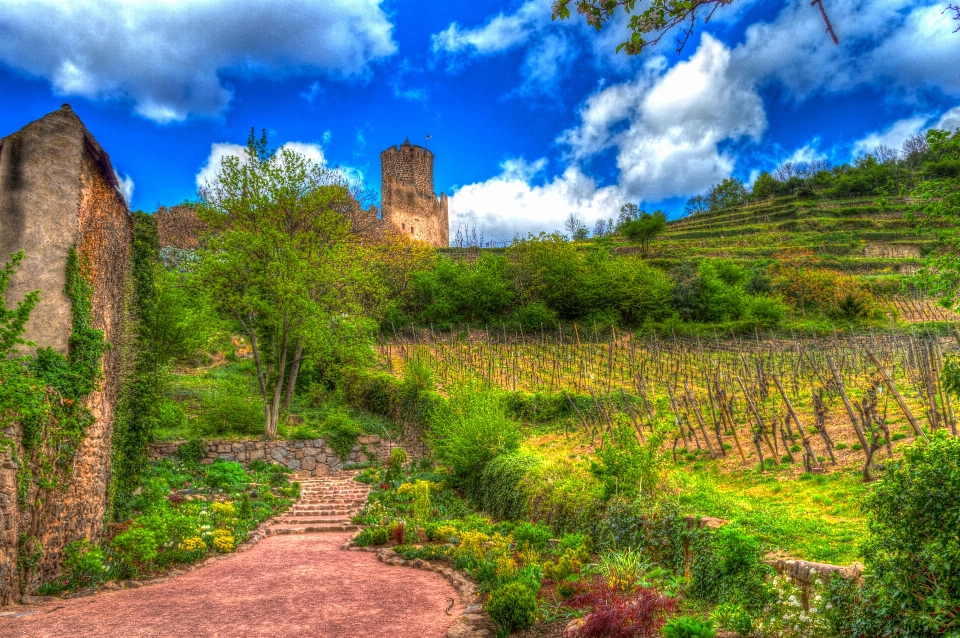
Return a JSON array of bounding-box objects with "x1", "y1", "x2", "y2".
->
[{"x1": 0, "y1": 0, "x2": 397, "y2": 122}]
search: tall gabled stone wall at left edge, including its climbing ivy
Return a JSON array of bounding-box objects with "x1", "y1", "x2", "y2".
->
[{"x1": 0, "y1": 108, "x2": 132, "y2": 604}]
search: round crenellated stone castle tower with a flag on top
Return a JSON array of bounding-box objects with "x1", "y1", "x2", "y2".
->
[{"x1": 380, "y1": 139, "x2": 450, "y2": 248}]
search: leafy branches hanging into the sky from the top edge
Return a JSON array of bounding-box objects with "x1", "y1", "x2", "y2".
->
[{"x1": 553, "y1": 0, "x2": 836, "y2": 55}]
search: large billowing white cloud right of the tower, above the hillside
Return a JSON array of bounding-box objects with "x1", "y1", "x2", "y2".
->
[{"x1": 561, "y1": 35, "x2": 767, "y2": 201}]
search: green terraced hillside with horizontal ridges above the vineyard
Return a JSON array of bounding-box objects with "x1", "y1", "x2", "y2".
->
[{"x1": 640, "y1": 197, "x2": 941, "y2": 280}]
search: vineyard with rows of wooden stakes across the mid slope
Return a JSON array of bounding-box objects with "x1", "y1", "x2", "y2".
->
[{"x1": 379, "y1": 324, "x2": 958, "y2": 480}]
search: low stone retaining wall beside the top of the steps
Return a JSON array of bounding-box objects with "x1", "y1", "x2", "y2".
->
[{"x1": 150, "y1": 434, "x2": 400, "y2": 476}]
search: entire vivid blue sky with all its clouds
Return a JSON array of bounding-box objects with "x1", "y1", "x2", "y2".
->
[{"x1": 0, "y1": 0, "x2": 960, "y2": 240}]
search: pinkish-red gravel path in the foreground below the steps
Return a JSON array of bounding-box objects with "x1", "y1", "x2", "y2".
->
[{"x1": 0, "y1": 533, "x2": 463, "y2": 638}]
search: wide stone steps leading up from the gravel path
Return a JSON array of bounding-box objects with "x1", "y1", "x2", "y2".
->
[{"x1": 267, "y1": 471, "x2": 370, "y2": 535}]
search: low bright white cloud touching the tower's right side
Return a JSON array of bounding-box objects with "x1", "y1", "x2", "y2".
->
[{"x1": 450, "y1": 159, "x2": 628, "y2": 241}]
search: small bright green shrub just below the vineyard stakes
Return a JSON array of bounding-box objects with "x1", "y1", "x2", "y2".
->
[{"x1": 590, "y1": 425, "x2": 666, "y2": 498}]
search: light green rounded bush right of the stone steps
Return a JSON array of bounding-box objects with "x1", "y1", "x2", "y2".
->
[{"x1": 429, "y1": 388, "x2": 520, "y2": 482}]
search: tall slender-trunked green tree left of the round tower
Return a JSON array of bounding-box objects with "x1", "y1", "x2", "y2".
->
[{"x1": 198, "y1": 131, "x2": 369, "y2": 439}]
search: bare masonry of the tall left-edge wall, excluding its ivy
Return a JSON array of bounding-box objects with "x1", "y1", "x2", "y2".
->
[{"x1": 0, "y1": 105, "x2": 133, "y2": 605}]
